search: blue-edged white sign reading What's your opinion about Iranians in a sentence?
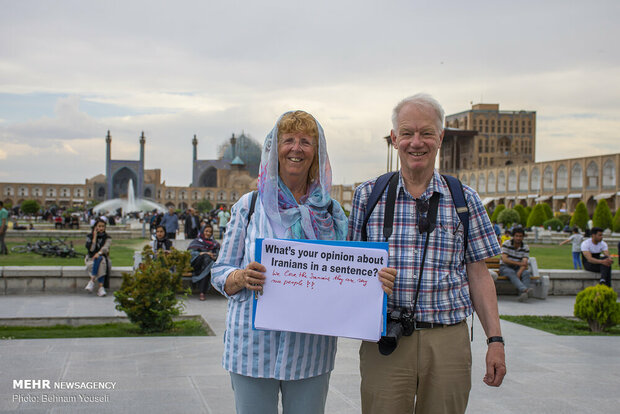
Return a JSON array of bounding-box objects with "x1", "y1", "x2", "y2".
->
[{"x1": 254, "y1": 239, "x2": 388, "y2": 341}]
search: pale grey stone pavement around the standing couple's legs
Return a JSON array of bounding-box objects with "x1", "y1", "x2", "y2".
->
[{"x1": 0, "y1": 294, "x2": 620, "y2": 414}]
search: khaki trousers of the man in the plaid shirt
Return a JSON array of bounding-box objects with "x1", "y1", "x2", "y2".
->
[{"x1": 360, "y1": 321, "x2": 471, "y2": 414}]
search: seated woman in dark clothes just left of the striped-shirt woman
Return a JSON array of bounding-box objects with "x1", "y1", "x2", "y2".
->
[{"x1": 187, "y1": 224, "x2": 220, "y2": 300}]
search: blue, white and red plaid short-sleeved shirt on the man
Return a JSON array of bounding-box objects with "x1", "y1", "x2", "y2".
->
[{"x1": 348, "y1": 171, "x2": 500, "y2": 324}]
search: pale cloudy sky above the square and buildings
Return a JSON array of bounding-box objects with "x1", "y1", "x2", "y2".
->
[{"x1": 0, "y1": 0, "x2": 620, "y2": 186}]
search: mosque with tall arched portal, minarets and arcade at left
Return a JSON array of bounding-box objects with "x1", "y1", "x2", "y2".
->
[{"x1": 0, "y1": 131, "x2": 256, "y2": 210}]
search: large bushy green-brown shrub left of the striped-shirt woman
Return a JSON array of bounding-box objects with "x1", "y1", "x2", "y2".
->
[{"x1": 114, "y1": 246, "x2": 191, "y2": 332}]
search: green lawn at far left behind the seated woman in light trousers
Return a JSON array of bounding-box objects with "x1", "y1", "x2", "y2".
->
[{"x1": 0, "y1": 237, "x2": 149, "y2": 266}]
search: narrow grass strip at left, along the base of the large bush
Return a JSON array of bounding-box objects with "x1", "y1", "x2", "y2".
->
[{"x1": 0, "y1": 320, "x2": 212, "y2": 339}]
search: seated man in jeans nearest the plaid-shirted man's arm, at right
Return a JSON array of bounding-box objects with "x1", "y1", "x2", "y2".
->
[{"x1": 499, "y1": 227, "x2": 534, "y2": 302}]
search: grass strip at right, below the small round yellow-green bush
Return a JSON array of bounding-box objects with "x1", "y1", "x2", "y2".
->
[{"x1": 500, "y1": 315, "x2": 620, "y2": 336}]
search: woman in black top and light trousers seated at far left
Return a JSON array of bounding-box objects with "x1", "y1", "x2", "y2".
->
[{"x1": 84, "y1": 219, "x2": 112, "y2": 296}]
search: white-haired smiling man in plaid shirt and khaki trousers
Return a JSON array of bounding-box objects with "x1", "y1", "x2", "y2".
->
[{"x1": 349, "y1": 94, "x2": 506, "y2": 414}]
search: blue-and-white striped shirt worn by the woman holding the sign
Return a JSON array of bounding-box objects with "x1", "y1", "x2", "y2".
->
[{"x1": 211, "y1": 193, "x2": 337, "y2": 380}]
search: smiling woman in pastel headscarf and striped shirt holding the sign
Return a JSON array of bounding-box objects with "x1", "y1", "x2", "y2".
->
[{"x1": 212, "y1": 111, "x2": 394, "y2": 414}]
